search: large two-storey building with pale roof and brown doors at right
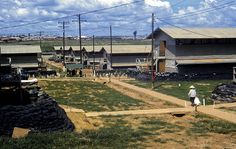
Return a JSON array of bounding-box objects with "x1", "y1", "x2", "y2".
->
[{"x1": 147, "y1": 28, "x2": 236, "y2": 73}]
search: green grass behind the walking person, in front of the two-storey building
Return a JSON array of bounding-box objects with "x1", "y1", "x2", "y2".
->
[{"x1": 127, "y1": 80, "x2": 231, "y2": 105}]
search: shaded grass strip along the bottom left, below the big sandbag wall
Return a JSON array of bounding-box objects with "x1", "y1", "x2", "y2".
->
[{"x1": 0, "y1": 118, "x2": 146, "y2": 149}]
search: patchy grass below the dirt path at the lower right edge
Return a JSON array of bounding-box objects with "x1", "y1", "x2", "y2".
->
[{"x1": 188, "y1": 114, "x2": 236, "y2": 135}]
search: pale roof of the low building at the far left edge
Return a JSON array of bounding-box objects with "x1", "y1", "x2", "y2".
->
[{"x1": 0, "y1": 45, "x2": 42, "y2": 54}]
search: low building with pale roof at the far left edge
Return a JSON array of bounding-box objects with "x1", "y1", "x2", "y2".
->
[{"x1": 0, "y1": 45, "x2": 42, "y2": 69}]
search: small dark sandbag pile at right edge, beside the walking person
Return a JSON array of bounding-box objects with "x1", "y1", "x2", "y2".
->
[{"x1": 212, "y1": 83, "x2": 236, "y2": 102}]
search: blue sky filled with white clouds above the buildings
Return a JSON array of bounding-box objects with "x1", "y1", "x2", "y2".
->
[{"x1": 0, "y1": 0, "x2": 236, "y2": 36}]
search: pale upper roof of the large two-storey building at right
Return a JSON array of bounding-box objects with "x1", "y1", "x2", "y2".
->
[{"x1": 147, "y1": 28, "x2": 236, "y2": 39}]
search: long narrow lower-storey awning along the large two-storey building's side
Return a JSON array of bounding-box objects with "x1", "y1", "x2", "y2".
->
[{"x1": 176, "y1": 59, "x2": 236, "y2": 65}]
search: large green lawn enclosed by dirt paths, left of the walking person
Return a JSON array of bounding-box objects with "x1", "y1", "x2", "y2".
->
[{"x1": 39, "y1": 80, "x2": 145, "y2": 111}]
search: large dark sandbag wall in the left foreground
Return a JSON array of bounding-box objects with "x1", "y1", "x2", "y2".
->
[{"x1": 0, "y1": 93, "x2": 74, "y2": 136}]
